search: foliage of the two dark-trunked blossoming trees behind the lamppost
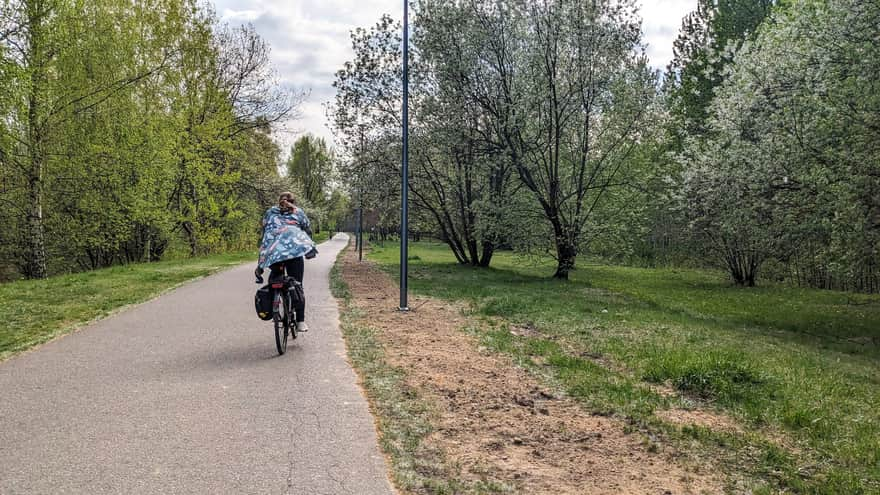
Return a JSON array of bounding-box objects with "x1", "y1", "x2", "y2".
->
[{"x1": 330, "y1": 1, "x2": 659, "y2": 278}]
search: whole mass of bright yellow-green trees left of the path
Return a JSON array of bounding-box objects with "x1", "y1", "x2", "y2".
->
[{"x1": 0, "y1": 0, "x2": 298, "y2": 278}]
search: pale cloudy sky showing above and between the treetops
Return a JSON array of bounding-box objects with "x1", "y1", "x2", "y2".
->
[{"x1": 214, "y1": 0, "x2": 697, "y2": 147}]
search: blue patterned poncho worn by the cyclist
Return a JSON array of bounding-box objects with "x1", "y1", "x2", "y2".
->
[{"x1": 260, "y1": 206, "x2": 315, "y2": 269}]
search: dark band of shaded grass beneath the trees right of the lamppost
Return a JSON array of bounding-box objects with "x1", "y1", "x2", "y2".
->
[{"x1": 402, "y1": 260, "x2": 880, "y2": 359}]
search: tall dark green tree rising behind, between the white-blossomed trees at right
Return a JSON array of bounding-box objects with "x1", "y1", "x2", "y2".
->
[{"x1": 645, "y1": 0, "x2": 778, "y2": 280}]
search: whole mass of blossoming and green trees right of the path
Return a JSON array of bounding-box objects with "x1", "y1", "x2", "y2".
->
[{"x1": 328, "y1": 0, "x2": 880, "y2": 291}]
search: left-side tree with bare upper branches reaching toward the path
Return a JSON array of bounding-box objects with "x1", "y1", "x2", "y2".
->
[{"x1": 168, "y1": 12, "x2": 302, "y2": 255}]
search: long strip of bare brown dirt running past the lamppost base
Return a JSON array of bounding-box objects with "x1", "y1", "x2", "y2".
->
[{"x1": 342, "y1": 251, "x2": 723, "y2": 494}]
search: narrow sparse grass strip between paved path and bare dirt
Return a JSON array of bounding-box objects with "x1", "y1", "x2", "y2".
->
[{"x1": 330, "y1": 246, "x2": 505, "y2": 495}]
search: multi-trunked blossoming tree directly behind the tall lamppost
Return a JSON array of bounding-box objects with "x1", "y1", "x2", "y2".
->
[{"x1": 331, "y1": 10, "x2": 511, "y2": 266}]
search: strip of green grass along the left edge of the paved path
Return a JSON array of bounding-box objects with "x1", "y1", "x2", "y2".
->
[{"x1": 0, "y1": 252, "x2": 256, "y2": 360}]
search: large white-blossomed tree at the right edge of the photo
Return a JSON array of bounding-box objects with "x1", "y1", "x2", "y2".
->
[{"x1": 688, "y1": 0, "x2": 880, "y2": 291}]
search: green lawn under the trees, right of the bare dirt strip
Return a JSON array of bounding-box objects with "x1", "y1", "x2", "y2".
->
[{"x1": 370, "y1": 243, "x2": 880, "y2": 494}]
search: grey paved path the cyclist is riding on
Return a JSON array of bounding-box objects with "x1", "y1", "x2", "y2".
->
[{"x1": 0, "y1": 235, "x2": 392, "y2": 495}]
